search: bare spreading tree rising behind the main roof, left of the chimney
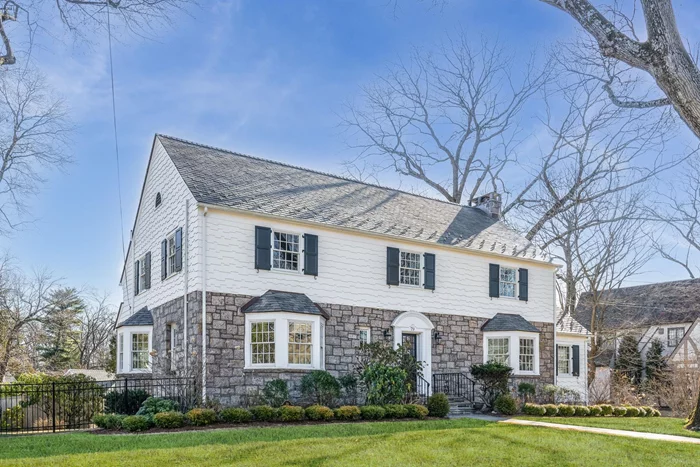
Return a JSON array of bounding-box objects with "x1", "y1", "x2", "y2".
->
[{"x1": 344, "y1": 35, "x2": 548, "y2": 203}]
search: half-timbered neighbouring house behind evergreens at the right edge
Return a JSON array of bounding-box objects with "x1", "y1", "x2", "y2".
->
[{"x1": 575, "y1": 279, "x2": 700, "y2": 368}]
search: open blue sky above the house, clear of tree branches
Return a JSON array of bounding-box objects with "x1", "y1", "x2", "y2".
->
[{"x1": 0, "y1": 0, "x2": 698, "y2": 302}]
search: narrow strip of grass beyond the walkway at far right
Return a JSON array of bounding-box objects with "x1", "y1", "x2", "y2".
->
[{"x1": 518, "y1": 417, "x2": 700, "y2": 438}]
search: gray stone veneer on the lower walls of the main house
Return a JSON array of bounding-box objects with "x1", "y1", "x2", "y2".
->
[{"x1": 135, "y1": 292, "x2": 554, "y2": 405}]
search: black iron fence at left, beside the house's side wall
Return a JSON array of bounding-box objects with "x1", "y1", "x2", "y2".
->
[{"x1": 0, "y1": 378, "x2": 199, "y2": 434}]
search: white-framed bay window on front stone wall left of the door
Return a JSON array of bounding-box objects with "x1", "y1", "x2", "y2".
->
[{"x1": 245, "y1": 312, "x2": 325, "y2": 370}]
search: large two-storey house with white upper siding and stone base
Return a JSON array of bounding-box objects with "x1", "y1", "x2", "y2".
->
[{"x1": 117, "y1": 135, "x2": 564, "y2": 404}]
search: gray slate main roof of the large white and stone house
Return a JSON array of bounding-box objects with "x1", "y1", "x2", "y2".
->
[{"x1": 157, "y1": 135, "x2": 548, "y2": 261}]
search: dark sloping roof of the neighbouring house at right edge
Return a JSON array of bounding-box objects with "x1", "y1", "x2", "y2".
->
[{"x1": 574, "y1": 279, "x2": 700, "y2": 330}]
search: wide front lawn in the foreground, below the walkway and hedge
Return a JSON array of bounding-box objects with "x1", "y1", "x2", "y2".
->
[{"x1": 0, "y1": 419, "x2": 698, "y2": 467}]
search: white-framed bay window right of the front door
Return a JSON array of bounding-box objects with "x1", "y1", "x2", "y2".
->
[{"x1": 484, "y1": 331, "x2": 540, "y2": 375}]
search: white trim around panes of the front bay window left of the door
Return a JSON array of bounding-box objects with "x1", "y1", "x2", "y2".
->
[{"x1": 244, "y1": 312, "x2": 325, "y2": 370}]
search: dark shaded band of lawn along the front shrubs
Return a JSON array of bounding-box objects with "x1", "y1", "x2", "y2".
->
[{"x1": 0, "y1": 419, "x2": 494, "y2": 459}]
